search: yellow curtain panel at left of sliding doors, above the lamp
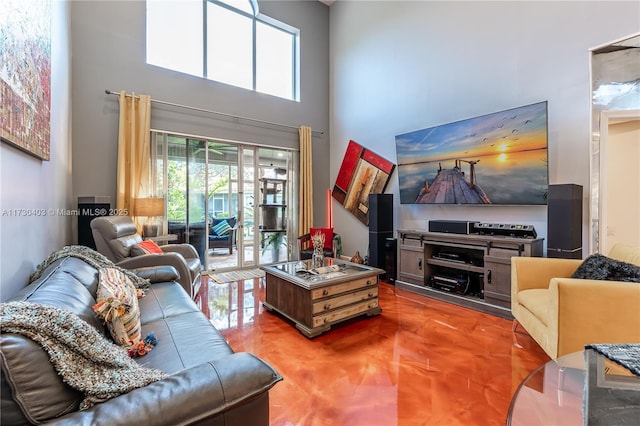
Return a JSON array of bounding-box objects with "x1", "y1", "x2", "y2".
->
[{"x1": 116, "y1": 91, "x2": 153, "y2": 226}]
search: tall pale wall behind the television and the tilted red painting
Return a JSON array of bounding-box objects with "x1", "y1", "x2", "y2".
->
[{"x1": 330, "y1": 1, "x2": 640, "y2": 254}]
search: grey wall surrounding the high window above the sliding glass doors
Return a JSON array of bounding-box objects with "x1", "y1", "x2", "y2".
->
[{"x1": 71, "y1": 0, "x2": 329, "y2": 230}]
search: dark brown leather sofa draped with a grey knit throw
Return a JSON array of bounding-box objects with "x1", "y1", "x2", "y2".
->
[{"x1": 0, "y1": 257, "x2": 282, "y2": 425}]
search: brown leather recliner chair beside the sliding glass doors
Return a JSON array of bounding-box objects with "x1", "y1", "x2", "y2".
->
[{"x1": 91, "y1": 216, "x2": 202, "y2": 300}]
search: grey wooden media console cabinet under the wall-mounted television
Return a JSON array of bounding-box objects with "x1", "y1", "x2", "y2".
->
[{"x1": 395, "y1": 230, "x2": 544, "y2": 318}]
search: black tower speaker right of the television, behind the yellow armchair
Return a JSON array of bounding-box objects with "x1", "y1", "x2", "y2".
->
[{"x1": 547, "y1": 184, "x2": 582, "y2": 259}]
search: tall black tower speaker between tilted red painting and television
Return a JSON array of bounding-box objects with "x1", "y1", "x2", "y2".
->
[{"x1": 369, "y1": 194, "x2": 393, "y2": 269}]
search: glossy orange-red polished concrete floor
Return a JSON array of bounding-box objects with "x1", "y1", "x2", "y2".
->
[{"x1": 203, "y1": 279, "x2": 549, "y2": 426}]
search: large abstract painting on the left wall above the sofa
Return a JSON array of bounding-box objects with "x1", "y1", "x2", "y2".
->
[{"x1": 0, "y1": 0, "x2": 51, "y2": 161}]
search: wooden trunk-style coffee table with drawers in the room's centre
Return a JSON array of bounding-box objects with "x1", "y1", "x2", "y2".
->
[{"x1": 262, "y1": 258, "x2": 384, "y2": 338}]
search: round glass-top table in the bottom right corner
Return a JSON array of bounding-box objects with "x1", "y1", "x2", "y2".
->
[{"x1": 507, "y1": 349, "x2": 640, "y2": 426}]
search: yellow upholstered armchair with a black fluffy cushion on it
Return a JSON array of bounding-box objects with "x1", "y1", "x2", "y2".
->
[{"x1": 511, "y1": 244, "x2": 640, "y2": 358}]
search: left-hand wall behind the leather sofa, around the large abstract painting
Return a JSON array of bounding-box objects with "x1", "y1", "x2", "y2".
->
[{"x1": 0, "y1": 1, "x2": 75, "y2": 301}]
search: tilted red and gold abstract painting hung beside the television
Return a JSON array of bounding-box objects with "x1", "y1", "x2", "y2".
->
[{"x1": 333, "y1": 141, "x2": 396, "y2": 226}]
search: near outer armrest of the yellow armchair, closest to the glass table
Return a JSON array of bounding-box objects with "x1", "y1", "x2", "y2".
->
[{"x1": 547, "y1": 278, "x2": 640, "y2": 356}]
